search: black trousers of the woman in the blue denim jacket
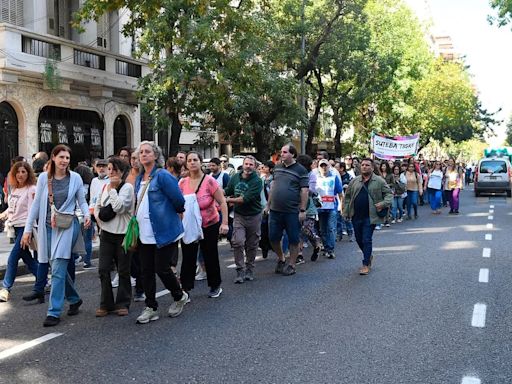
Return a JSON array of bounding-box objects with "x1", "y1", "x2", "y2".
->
[{"x1": 138, "y1": 241, "x2": 182, "y2": 310}]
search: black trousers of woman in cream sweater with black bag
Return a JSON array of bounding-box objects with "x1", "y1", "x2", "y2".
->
[{"x1": 98, "y1": 231, "x2": 132, "y2": 311}]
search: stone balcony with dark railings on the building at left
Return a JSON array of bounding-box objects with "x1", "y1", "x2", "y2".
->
[{"x1": 0, "y1": 23, "x2": 149, "y2": 94}]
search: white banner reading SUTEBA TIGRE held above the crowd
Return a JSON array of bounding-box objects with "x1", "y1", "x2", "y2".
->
[{"x1": 371, "y1": 132, "x2": 420, "y2": 160}]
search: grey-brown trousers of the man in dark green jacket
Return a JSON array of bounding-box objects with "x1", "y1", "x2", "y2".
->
[{"x1": 231, "y1": 213, "x2": 261, "y2": 270}]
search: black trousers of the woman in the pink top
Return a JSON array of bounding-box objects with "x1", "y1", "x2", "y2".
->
[{"x1": 181, "y1": 223, "x2": 222, "y2": 291}]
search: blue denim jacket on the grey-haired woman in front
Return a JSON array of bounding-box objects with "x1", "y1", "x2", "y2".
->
[{"x1": 135, "y1": 166, "x2": 185, "y2": 248}]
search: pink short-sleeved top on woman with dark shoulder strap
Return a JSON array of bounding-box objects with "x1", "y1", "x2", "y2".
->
[{"x1": 179, "y1": 175, "x2": 220, "y2": 228}]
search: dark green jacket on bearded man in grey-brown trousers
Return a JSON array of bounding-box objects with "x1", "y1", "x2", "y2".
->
[{"x1": 224, "y1": 172, "x2": 263, "y2": 216}]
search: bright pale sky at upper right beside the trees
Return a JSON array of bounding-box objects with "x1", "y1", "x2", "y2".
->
[{"x1": 405, "y1": 0, "x2": 512, "y2": 146}]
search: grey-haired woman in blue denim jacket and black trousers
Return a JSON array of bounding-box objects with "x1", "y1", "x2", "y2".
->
[{"x1": 135, "y1": 141, "x2": 188, "y2": 324}]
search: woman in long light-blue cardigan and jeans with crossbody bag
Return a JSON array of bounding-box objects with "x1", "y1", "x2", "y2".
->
[{"x1": 21, "y1": 144, "x2": 91, "y2": 327}]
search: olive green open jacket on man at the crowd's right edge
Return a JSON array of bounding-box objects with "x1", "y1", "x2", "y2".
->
[{"x1": 343, "y1": 173, "x2": 393, "y2": 224}]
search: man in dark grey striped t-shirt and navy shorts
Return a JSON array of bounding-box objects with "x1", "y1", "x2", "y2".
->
[{"x1": 265, "y1": 144, "x2": 309, "y2": 276}]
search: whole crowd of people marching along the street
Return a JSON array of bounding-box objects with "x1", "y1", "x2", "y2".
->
[{"x1": 0, "y1": 141, "x2": 465, "y2": 327}]
